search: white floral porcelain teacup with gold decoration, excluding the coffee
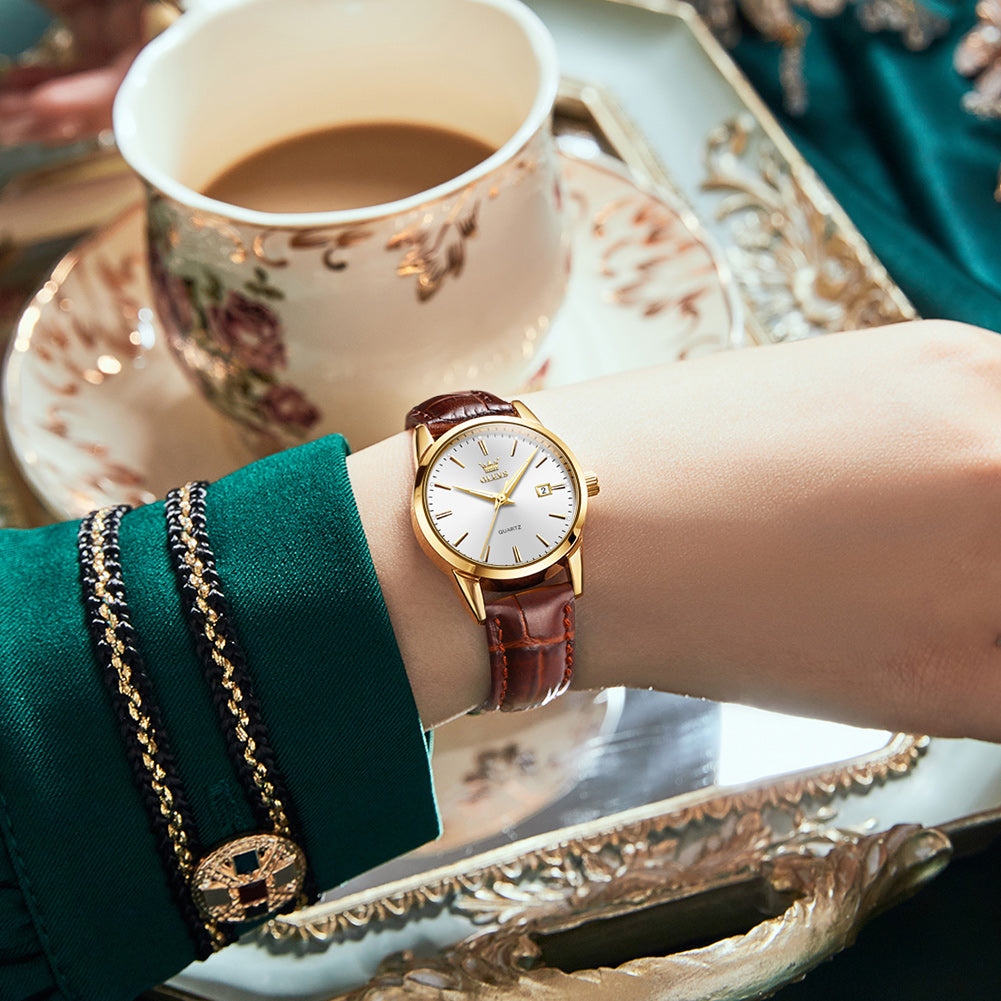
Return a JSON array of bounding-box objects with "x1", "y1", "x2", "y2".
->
[{"x1": 114, "y1": 0, "x2": 570, "y2": 450}]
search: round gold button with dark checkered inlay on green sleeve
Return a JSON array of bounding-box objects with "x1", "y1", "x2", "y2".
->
[{"x1": 191, "y1": 834, "x2": 306, "y2": 923}]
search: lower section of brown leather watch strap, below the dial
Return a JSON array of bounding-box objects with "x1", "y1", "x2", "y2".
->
[{"x1": 479, "y1": 582, "x2": 574, "y2": 712}]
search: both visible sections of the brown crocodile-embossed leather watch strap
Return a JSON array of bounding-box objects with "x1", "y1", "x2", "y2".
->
[{"x1": 406, "y1": 390, "x2": 574, "y2": 712}]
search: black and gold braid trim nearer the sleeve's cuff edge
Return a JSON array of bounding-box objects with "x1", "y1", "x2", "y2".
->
[{"x1": 179, "y1": 483, "x2": 291, "y2": 838}]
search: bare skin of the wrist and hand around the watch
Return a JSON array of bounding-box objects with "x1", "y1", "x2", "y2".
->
[{"x1": 349, "y1": 324, "x2": 1001, "y2": 738}]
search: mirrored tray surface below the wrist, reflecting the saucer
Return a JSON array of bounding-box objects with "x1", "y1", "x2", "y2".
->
[{"x1": 324, "y1": 689, "x2": 891, "y2": 903}]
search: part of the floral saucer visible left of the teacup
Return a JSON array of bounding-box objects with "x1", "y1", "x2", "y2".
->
[{"x1": 4, "y1": 205, "x2": 262, "y2": 518}]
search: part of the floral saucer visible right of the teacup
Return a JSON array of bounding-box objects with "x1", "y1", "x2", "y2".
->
[{"x1": 528, "y1": 154, "x2": 744, "y2": 389}]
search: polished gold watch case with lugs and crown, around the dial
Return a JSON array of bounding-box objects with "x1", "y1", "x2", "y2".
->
[{"x1": 410, "y1": 399, "x2": 598, "y2": 623}]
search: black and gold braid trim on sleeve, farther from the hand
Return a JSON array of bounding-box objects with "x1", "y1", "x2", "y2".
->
[{"x1": 77, "y1": 506, "x2": 227, "y2": 959}]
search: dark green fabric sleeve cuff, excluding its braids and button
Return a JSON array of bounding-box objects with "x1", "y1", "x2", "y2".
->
[{"x1": 0, "y1": 436, "x2": 438, "y2": 1001}]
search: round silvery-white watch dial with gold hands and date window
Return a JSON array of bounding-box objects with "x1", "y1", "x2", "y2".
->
[{"x1": 423, "y1": 421, "x2": 581, "y2": 567}]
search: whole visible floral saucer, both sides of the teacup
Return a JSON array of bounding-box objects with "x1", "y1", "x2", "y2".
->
[{"x1": 4, "y1": 153, "x2": 743, "y2": 518}]
